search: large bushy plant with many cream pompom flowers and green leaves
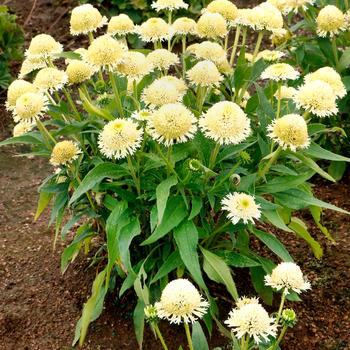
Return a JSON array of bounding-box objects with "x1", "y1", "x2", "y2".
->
[{"x1": 1, "y1": 0, "x2": 350, "y2": 344}]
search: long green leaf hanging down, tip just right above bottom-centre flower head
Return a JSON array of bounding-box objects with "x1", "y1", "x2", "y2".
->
[{"x1": 174, "y1": 221, "x2": 207, "y2": 290}]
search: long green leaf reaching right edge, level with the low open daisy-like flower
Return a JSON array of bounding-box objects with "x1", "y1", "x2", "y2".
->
[{"x1": 274, "y1": 189, "x2": 350, "y2": 214}]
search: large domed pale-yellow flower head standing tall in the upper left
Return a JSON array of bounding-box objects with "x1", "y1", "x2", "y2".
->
[{"x1": 84, "y1": 34, "x2": 125, "y2": 69}]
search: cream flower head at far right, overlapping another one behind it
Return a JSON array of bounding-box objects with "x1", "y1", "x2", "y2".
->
[{"x1": 294, "y1": 80, "x2": 338, "y2": 118}]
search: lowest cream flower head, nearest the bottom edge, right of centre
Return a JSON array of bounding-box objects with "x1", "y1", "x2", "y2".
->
[{"x1": 225, "y1": 304, "x2": 277, "y2": 344}]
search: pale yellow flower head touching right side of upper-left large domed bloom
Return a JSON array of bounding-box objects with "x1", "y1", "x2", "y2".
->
[{"x1": 117, "y1": 51, "x2": 151, "y2": 79}]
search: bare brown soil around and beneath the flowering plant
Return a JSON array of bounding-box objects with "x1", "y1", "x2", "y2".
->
[{"x1": 0, "y1": 0, "x2": 350, "y2": 350}]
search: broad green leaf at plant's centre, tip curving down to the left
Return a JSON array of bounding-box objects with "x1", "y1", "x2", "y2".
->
[{"x1": 141, "y1": 197, "x2": 187, "y2": 245}]
